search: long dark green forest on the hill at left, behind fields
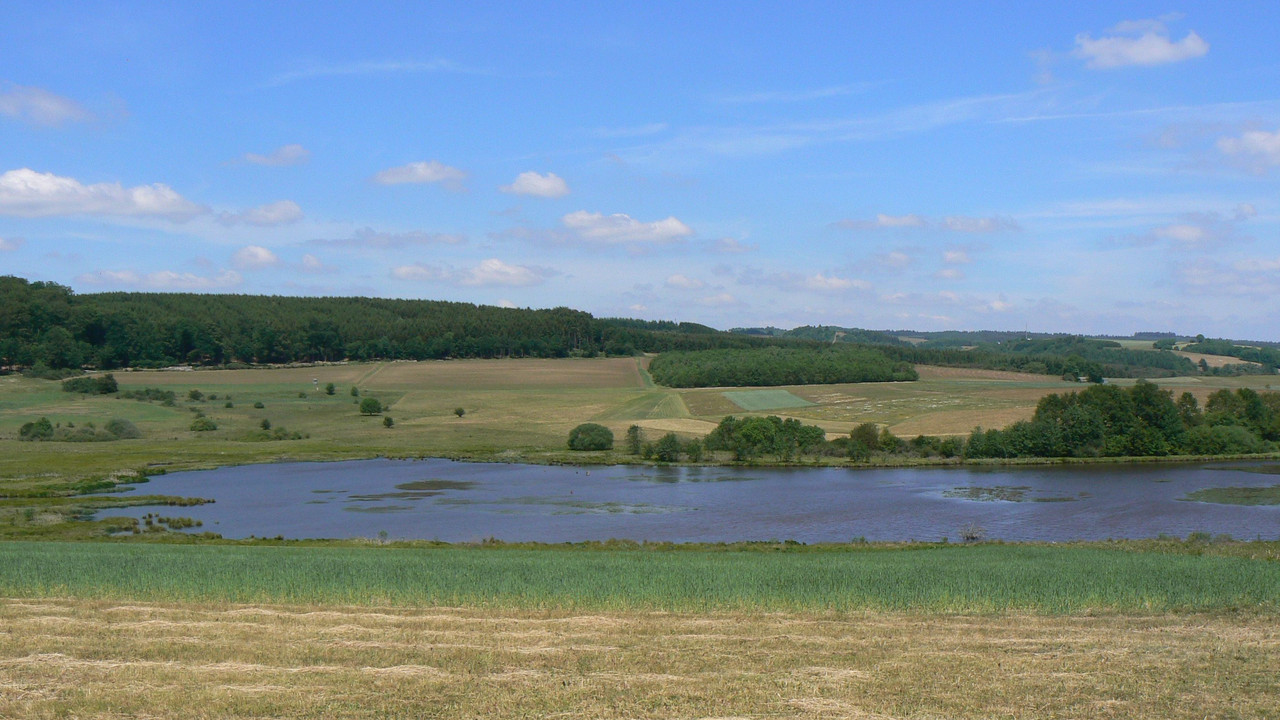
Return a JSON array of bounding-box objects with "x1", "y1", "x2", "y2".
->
[{"x1": 0, "y1": 277, "x2": 792, "y2": 369}]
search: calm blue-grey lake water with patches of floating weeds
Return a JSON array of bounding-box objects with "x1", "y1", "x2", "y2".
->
[{"x1": 112, "y1": 460, "x2": 1280, "y2": 542}]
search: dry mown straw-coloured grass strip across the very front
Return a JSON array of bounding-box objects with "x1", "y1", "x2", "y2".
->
[{"x1": 0, "y1": 600, "x2": 1280, "y2": 719}]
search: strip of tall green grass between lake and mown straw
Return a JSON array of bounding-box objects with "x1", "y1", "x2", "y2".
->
[{"x1": 0, "y1": 542, "x2": 1280, "y2": 614}]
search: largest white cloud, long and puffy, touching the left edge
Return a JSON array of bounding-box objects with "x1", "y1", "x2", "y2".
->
[{"x1": 0, "y1": 168, "x2": 209, "y2": 222}]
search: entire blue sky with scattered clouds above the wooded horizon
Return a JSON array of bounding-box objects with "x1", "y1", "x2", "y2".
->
[{"x1": 0, "y1": 0, "x2": 1280, "y2": 341}]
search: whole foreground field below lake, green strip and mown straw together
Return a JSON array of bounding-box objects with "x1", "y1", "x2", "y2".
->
[{"x1": 0, "y1": 543, "x2": 1280, "y2": 719}]
